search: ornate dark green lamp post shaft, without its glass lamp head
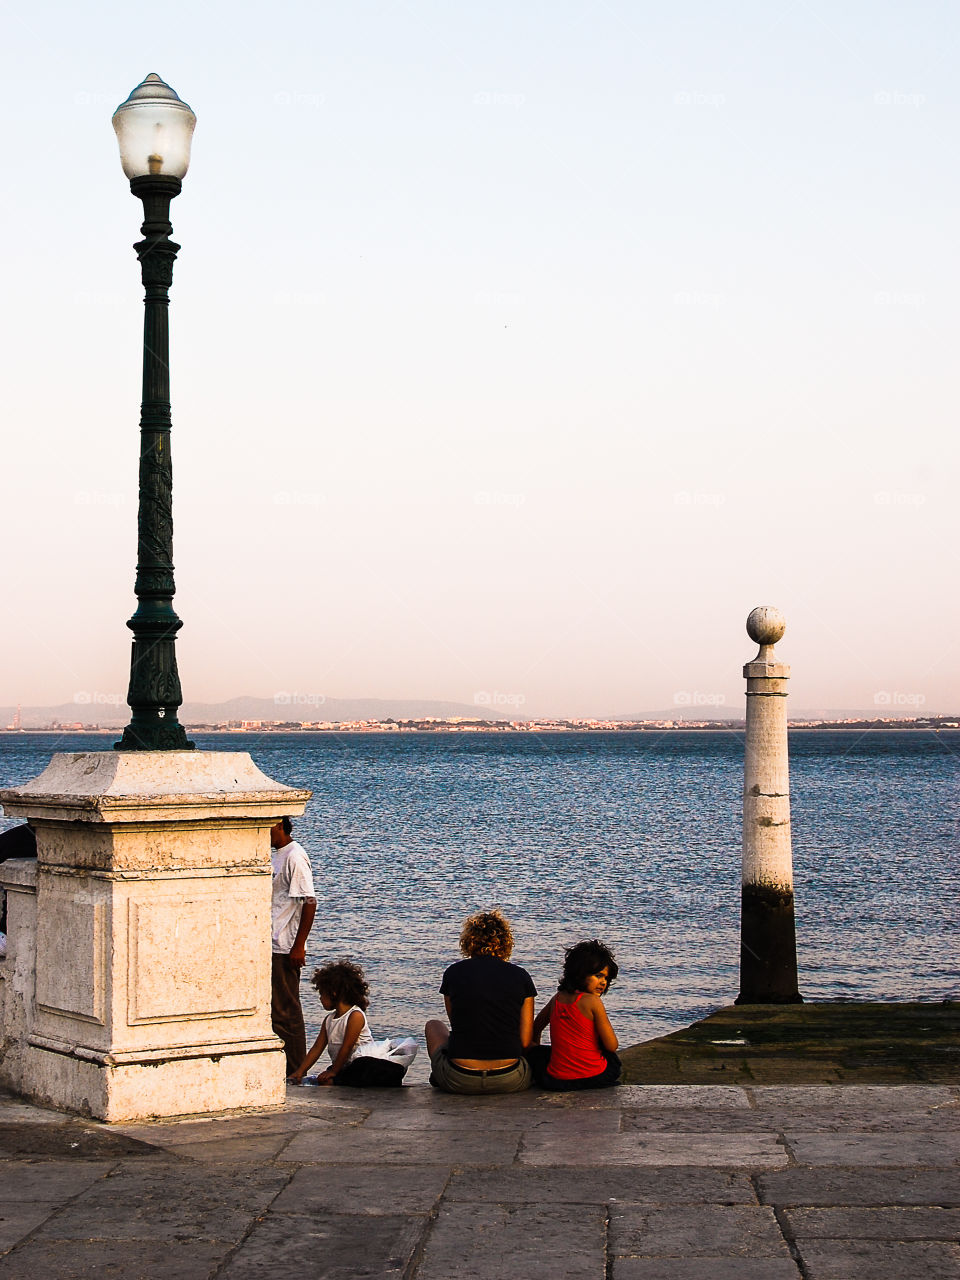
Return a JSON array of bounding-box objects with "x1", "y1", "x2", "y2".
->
[{"x1": 116, "y1": 174, "x2": 193, "y2": 751}]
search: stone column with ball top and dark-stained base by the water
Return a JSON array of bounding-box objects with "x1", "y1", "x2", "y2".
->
[{"x1": 736, "y1": 605, "x2": 803, "y2": 1005}]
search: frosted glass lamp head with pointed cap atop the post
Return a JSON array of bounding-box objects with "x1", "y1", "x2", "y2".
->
[{"x1": 114, "y1": 72, "x2": 197, "y2": 179}]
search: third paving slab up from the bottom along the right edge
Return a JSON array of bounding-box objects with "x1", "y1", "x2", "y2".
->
[{"x1": 756, "y1": 1166, "x2": 960, "y2": 1207}]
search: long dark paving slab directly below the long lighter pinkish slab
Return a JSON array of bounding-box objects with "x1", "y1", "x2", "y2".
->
[{"x1": 444, "y1": 1166, "x2": 756, "y2": 1206}]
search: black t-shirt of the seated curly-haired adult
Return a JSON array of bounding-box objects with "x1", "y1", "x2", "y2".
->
[{"x1": 440, "y1": 956, "x2": 536, "y2": 1060}]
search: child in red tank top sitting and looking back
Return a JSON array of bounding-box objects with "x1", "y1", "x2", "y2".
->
[{"x1": 527, "y1": 938, "x2": 621, "y2": 1091}]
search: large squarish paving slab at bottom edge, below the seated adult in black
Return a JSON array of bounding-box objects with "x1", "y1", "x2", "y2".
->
[{"x1": 416, "y1": 1203, "x2": 605, "y2": 1280}]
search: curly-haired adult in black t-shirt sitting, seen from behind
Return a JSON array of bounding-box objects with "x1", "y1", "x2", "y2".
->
[{"x1": 424, "y1": 911, "x2": 536, "y2": 1093}]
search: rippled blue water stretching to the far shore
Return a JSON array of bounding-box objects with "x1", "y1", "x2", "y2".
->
[{"x1": 0, "y1": 731, "x2": 960, "y2": 1070}]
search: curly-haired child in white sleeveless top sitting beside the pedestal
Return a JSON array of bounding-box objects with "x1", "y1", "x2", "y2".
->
[{"x1": 289, "y1": 960, "x2": 417, "y2": 1088}]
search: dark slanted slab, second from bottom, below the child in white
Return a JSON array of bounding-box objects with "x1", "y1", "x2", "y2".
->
[{"x1": 270, "y1": 1165, "x2": 451, "y2": 1215}]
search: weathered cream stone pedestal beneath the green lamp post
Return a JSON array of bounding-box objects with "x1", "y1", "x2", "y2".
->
[{"x1": 0, "y1": 751, "x2": 310, "y2": 1121}]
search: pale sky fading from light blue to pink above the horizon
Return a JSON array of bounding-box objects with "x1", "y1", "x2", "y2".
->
[{"x1": 0, "y1": 0, "x2": 960, "y2": 716}]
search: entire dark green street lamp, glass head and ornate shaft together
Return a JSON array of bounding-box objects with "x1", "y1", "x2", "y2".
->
[{"x1": 113, "y1": 74, "x2": 197, "y2": 751}]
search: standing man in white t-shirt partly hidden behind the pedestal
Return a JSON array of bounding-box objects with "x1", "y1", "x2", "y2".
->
[{"x1": 270, "y1": 818, "x2": 316, "y2": 1075}]
